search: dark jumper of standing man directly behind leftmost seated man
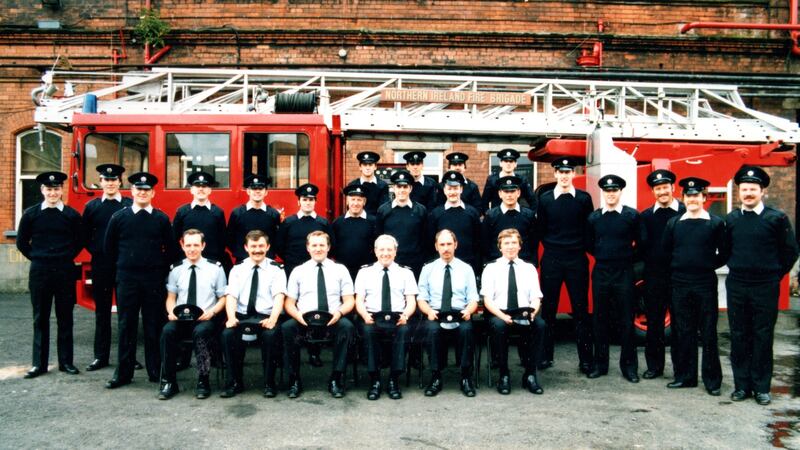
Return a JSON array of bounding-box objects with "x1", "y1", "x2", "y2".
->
[{"x1": 172, "y1": 203, "x2": 227, "y2": 262}]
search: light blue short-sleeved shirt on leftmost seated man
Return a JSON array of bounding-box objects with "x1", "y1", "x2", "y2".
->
[{"x1": 167, "y1": 258, "x2": 227, "y2": 311}]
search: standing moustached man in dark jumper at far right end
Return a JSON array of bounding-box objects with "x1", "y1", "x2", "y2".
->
[{"x1": 725, "y1": 166, "x2": 798, "y2": 405}]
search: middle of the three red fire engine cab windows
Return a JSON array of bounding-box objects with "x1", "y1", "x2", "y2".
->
[{"x1": 166, "y1": 133, "x2": 231, "y2": 189}]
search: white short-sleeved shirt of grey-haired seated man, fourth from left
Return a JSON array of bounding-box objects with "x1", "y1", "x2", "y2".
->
[{"x1": 356, "y1": 262, "x2": 417, "y2": 312}]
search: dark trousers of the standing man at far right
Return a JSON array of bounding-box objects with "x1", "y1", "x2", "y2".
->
[{"x1": 725, "y1": 276, "x2": 780, "y2": 393}]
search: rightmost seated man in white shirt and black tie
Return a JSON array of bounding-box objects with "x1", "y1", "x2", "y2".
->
[{"x1": 481, "y1": 228, "x2": 546, "y2": 395}]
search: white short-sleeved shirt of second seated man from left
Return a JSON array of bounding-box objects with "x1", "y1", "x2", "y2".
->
[{"x1": 225, "y1": 258, "x2": 286, "y2": 315}]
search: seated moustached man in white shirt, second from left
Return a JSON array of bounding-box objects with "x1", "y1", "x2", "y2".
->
[{"x1": 220, "y1": 230, "x2": 286, "y2": 398}]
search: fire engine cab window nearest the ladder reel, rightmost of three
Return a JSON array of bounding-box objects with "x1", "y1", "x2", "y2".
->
[{"x1": 244, "y1": 133, "x2": 309, "y2": 189}]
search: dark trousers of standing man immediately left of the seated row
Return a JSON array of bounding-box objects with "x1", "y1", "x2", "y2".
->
[{"x1": 116, "y1": 277, "x2": 167, "y2": 381}]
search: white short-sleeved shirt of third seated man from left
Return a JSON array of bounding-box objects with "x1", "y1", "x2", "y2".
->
[{"x1": 286, "y1": 258, "x2": 355, "y2": 314}]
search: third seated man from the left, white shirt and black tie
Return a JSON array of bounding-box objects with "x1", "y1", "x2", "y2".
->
[{"x1": 281, "y1": 231, "x2": 355, "y2": 398}]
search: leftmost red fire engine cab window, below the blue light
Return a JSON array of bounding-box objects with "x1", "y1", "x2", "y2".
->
[{"x1": 83, "y1": 133, "x2": 150, "y2": 189}]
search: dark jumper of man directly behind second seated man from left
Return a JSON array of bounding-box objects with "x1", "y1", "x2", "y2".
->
[{"x1": 227, "y1": 204, "x2": 281, "y2": 262}]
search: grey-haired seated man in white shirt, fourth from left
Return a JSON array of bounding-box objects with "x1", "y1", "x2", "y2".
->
[{"x1": 356, "y1": 234, "x2": 417, "y2": 400}]
